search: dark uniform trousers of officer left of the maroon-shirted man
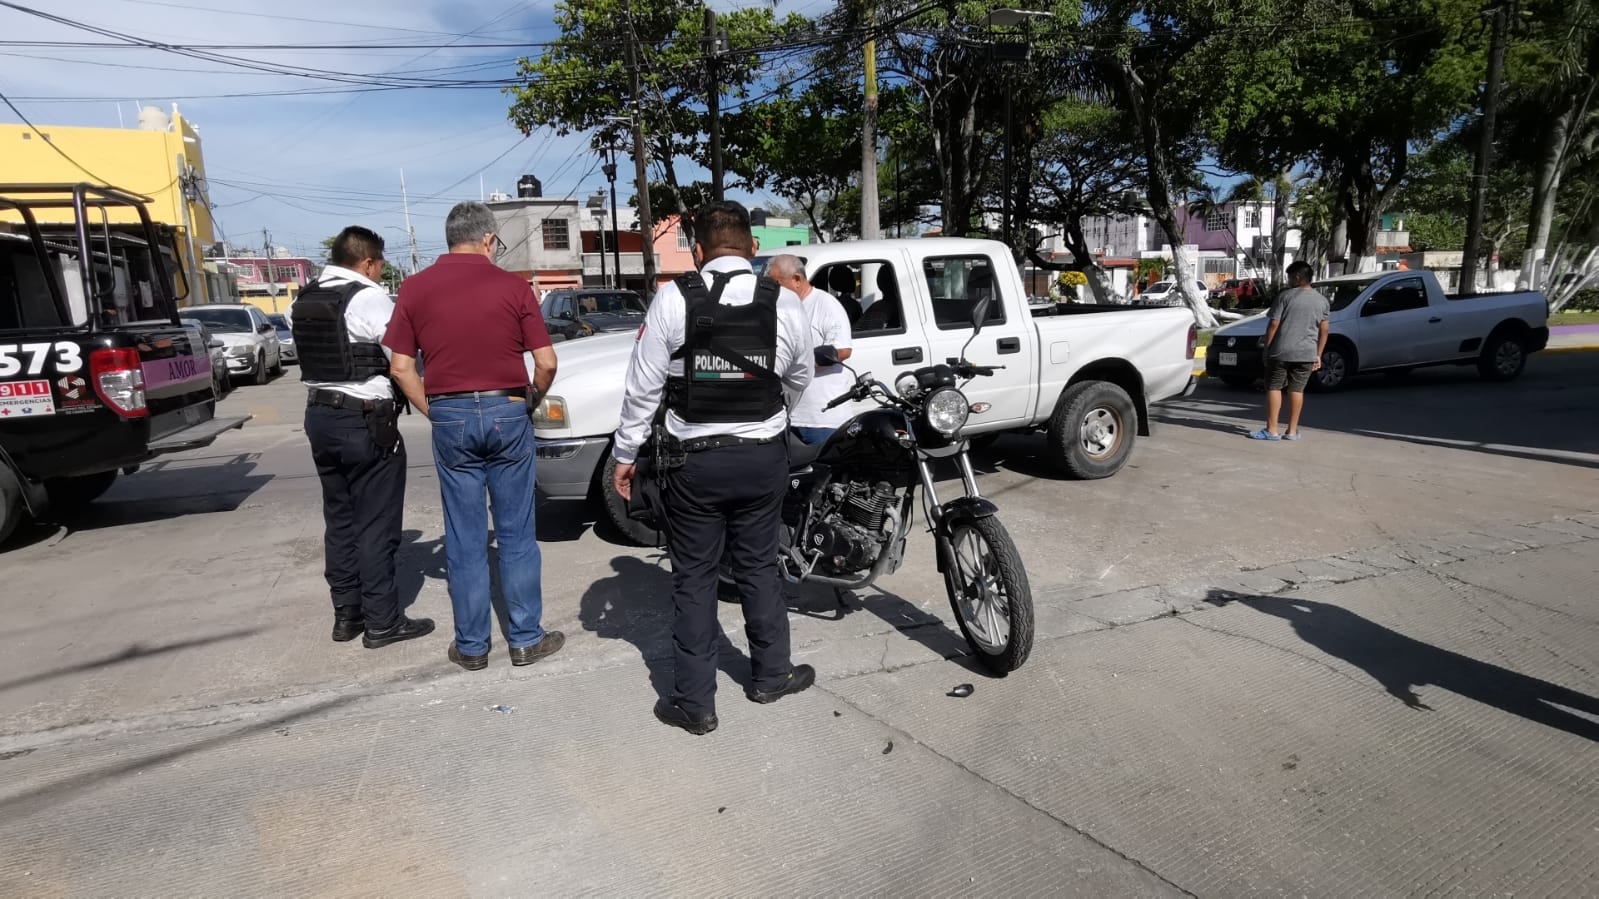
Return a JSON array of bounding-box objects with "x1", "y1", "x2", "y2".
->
[{"x1": 305, "y1": 405, "x2": 406, "y2": 630}]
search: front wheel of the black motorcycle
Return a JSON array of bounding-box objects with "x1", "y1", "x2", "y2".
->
[{"x1": 943, "y1": 518, "x2": 1033, "y2": 675}]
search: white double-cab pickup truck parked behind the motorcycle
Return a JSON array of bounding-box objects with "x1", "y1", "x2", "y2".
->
[{"x1": 534, "y1": 238, "x2": 1196, "y2": 539}]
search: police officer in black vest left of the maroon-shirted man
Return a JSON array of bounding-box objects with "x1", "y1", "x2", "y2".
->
[{"x1": 288, "y1": 226, "x2": 433, "y2": 649}]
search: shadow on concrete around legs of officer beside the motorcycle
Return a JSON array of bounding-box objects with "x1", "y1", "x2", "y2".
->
[{"x1": 577, "y1": 555, "x2": 753, "y2": 697}]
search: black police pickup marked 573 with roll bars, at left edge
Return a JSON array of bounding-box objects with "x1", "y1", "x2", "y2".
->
[{"x1": 0, "y1": 184, "x2": 249, "y2": 542}]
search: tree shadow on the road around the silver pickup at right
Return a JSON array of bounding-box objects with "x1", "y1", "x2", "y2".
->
[{"x1": 1153, "y1": 354, "x2": 1599, "y2": 469}]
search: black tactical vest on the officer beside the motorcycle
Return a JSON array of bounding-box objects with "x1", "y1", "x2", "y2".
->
[{"x1": 667, "y1": 272, "x2": 784, "y2": 424}]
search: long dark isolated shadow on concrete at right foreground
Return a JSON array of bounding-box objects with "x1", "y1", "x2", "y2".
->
[{"x1": 1206, "y1": 590, "x2": 1599, "y2": 741}]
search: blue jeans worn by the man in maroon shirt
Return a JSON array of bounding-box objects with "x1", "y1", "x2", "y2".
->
[{"x1": 429, "y1": 397, "x2": 544, "y2": 656}]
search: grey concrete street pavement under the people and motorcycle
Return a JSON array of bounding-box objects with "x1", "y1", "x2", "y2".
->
[{"x1": 0, "y1": 354, "x2": 1599, "y2": 896}]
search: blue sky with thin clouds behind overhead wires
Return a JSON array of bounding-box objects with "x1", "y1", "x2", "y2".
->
[{"x1": 0, "y1": 0, "x2": 799, "y2": 264}]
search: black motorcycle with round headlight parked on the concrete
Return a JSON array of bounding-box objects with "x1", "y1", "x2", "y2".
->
[{"x1": 748, "y1": 302, "x2": 1033, "y2": 675}]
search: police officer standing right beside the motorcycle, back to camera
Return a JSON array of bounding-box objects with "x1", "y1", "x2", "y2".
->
[{"x1": 612, "y1": 203, "x2": 815, "y2": 734}]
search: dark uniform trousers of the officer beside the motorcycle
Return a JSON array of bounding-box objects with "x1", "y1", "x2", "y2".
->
[{"x1": 664, "y1": 442, "x2": 793, "y2": 713}]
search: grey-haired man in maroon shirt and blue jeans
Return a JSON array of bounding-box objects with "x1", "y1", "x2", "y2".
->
[{"x1": 384, "y1": 203, "x2": 566, "y2": 670}]
